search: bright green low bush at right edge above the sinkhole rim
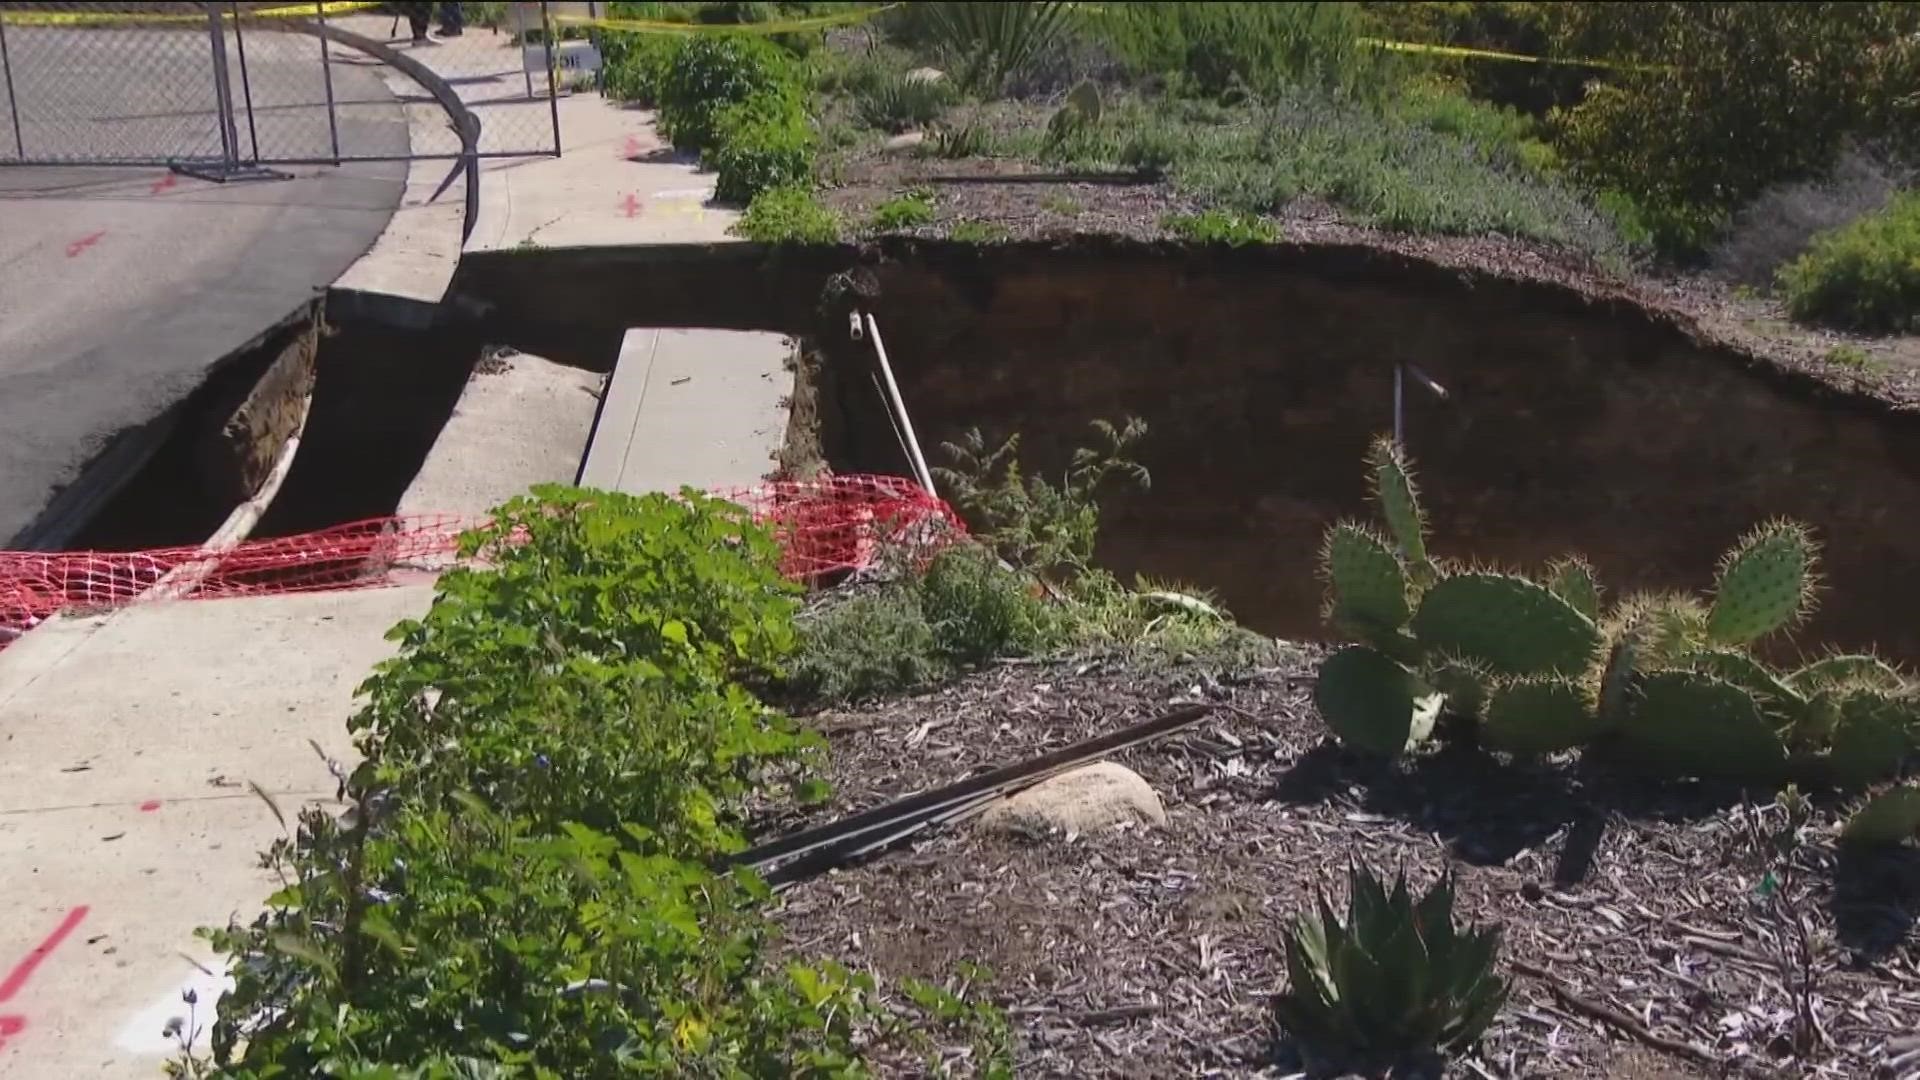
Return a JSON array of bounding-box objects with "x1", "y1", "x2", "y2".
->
[{"x1": 1780, "y1": 190, "x2": 1920, "y2": 332}]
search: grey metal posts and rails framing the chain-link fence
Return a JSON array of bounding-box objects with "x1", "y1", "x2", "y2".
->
[{"x1": 0, "y1": 0, "x2": 561, "y2": 171}]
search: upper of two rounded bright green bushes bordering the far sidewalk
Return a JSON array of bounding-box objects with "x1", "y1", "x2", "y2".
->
[{"x1": 660, "y1": 35, "x2": 801, "y2": 150}]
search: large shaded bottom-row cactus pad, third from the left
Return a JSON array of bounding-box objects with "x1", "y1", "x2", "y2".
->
[{"x1": 1624, "y1": 671, "x2": 1788, "y2": 782}]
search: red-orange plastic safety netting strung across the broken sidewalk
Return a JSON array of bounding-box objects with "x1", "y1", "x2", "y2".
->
[{"x1": 0, "y1": 477, "x2": 966, "y2": 648}]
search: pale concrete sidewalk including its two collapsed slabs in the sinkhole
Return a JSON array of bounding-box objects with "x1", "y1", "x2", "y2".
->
[{"x1": 0, "y1": 50, "x2": 793, "y2": 1080}]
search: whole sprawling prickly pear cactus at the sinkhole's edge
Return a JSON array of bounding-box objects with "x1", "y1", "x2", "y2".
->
[{"x1": 1315, "y1": 438, "x2": 1920, "y2": 786}]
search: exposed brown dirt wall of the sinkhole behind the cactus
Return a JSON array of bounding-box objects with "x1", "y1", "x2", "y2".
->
[{"x1": 818, "y1": 250, "x2": 1920, "y2": 661}]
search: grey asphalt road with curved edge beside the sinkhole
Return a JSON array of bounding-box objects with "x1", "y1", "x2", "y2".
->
[{"x1": 0, "y1": 27, "x2": 407, "y2": 548}]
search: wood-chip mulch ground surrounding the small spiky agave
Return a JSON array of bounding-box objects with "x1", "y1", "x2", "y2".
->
[{"x1": 774, "y1": 646, "x2": 1920, "y2": 1078}]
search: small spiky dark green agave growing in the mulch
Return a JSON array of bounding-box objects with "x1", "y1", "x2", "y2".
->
[{"x1": 1273, "y1": 865, "x2": 1507, "y2": 1065}]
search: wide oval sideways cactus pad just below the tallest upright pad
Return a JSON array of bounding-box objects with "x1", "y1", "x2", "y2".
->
[{"x1": 1413, "y1": 573, "x2": 1599, "y2": 675}]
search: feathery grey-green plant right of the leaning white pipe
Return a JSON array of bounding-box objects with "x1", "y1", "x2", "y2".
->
[{"x1": 933, "y1": 417, "x2": 1152, "y2": 577}]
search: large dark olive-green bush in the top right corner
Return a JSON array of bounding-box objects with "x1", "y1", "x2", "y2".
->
[{"x1": 1555, "y1": 2, "x2": 1920, "y2": 258}]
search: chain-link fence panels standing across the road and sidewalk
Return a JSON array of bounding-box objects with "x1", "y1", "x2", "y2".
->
[{"x1": 0, "y1": 2, "x2": 561, "y2": 173}]
